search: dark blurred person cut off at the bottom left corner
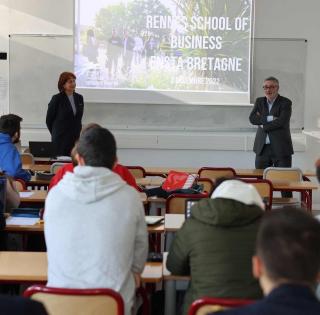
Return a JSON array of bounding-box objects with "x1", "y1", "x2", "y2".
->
[{"x1": 0, "y1": 295, "x2": 47, "y2": 315}]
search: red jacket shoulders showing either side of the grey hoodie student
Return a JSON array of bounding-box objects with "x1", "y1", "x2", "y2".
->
[{"x1": 49, "y1": 163, "x2": 139, "y2": 191}]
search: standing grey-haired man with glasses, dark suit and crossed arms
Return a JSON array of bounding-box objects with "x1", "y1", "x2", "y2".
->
[{"x1": 249, "y1": 77, "x2": 293, "y2": 197}]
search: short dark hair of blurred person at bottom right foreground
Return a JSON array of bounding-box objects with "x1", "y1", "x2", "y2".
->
[{"x1": 256, "y1": 208, "x2": 320, "y2": 284}]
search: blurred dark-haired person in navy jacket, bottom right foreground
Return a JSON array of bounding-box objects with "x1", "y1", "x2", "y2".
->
[{"x1": 212, "y1": 209, "x2": 320, "y2": 315}]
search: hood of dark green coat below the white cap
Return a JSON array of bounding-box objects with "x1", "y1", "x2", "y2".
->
[{"x1": 191, "y1": 198, "x2": 263, "y2": 227}]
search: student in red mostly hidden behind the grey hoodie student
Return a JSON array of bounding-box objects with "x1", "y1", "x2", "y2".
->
[{"x1": 49, "y1": 123, "x2": 139, "y2": 191}]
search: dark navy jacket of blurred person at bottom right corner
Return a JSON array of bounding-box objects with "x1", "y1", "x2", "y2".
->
[{"x1": 211, "y1": 284, "x2": 320, "y2": 315}]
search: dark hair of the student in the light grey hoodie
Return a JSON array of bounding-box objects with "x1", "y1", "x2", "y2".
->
[{"x1": 76, "y1": 127, "x2": 117, "y2": 169}]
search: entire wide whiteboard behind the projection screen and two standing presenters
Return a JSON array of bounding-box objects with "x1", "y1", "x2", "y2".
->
[{"x1": 9, "y1": 35, "x2": 307, "y2": 131}]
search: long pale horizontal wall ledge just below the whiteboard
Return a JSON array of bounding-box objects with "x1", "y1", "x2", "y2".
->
[{"x1": 21, "y1": 129, "x2": 307, "y2": 152}]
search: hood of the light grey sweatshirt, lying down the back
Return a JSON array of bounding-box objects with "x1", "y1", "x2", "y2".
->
[{"x1": 53, "y1": 166, "x2": 126, "y2": 203}]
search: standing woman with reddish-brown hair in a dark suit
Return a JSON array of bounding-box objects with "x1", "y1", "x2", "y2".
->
[{"x1": 46, "y1": 72, "x2": 83, "y2": 156}]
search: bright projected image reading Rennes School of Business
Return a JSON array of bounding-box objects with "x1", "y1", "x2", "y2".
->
[{"x1": 74, "y1": 0, "x2": 252, "y2": 93}]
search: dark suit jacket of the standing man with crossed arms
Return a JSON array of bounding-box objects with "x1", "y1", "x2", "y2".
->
[{"x1": 249, "y1": 95, "x2": 293, "y2": 158}]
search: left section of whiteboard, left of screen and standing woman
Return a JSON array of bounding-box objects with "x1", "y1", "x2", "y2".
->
[{"x1": 9, "y1": 35, "x2": 73, "y2": 125}]
